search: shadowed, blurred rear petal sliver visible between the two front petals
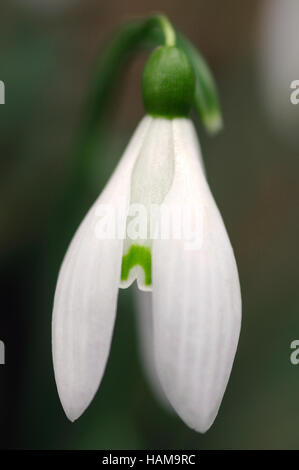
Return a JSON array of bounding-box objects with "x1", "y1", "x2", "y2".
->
[{"x1": 134, "y1": 288, "x2": 170, "y2": 408}]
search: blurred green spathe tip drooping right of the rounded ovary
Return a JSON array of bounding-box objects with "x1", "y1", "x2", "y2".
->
[{"x1": 177, "y1": 33, "x2": 222, "y2": 134}]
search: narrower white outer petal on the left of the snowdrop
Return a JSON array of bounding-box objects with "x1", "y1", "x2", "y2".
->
[{"x1": 52, "y1": 117, "x2": 151, "y2": 421}]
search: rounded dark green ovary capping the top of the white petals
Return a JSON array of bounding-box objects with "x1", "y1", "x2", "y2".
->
[{"x1": 142, "y1": 46, "x2": 195, "y2": 119}]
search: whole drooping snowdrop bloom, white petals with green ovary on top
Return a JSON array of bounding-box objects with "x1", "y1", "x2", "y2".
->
[{"x1": 53, "y1": 42, "x2": 241, "y2": 432}]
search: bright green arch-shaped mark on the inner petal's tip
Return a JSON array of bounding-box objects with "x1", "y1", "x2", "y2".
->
[{"x1": 121, "y1": 245, "x2": 152, "y2": 286}]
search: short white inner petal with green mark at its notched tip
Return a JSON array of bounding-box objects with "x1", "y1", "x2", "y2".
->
[{"x1": 120, "y1": 118, "x2": 174, "y2": 290}]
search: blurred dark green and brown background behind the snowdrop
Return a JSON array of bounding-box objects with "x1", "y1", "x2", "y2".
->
[{"x1": 0, "y1": 0, "x2": 299, "y2": 449}]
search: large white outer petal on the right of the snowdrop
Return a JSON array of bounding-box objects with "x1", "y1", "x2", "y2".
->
[{"x1": 153, "y1": 119, "x2": 241, "y2": 432}]
